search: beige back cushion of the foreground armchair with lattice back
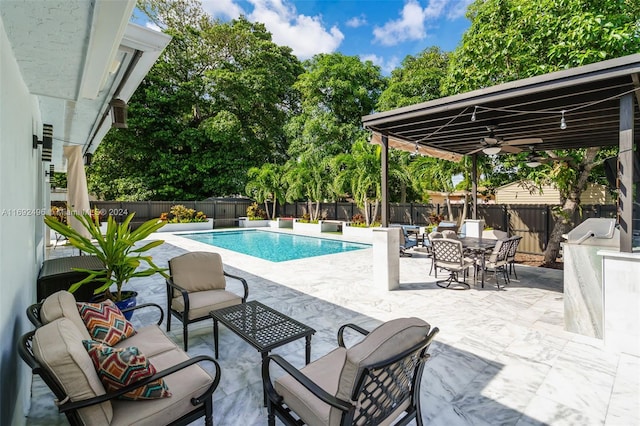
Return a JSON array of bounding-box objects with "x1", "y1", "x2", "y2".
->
[{"x1": 336, "y1": 318, "x2": 431, "y2": 400}]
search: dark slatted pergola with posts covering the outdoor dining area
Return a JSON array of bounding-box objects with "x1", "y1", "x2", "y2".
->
[{"x1": 362, "y1": 54, "x2": 640, "y2": 252}]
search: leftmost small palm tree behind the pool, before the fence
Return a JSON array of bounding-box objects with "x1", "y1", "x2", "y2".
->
[{"x1": 245, "y1": 163, "x2": 284, "y2": 219}]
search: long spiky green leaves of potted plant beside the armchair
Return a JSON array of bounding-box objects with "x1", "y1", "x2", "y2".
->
[{"x1": 44, "y1": 213, "x2": 167, "y2": 310}]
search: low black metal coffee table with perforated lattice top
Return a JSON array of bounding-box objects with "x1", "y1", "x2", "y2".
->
[{"x1": 209, "y1": 300, "x2": 316, "y2": 364}]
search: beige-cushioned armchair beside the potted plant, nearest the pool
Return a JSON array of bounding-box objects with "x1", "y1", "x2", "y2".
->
[{"x1": 167, "y1": 252, "x2": 249, "y2": 351}]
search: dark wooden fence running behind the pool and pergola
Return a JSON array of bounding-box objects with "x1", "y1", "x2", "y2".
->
[{"x1": 92, "y1": 198, "x2": 616, "y2": 254}]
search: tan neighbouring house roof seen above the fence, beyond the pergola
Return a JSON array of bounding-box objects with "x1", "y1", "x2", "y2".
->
[{"x1": 496, "y1": 182, "x2": 613, "y2": 204}]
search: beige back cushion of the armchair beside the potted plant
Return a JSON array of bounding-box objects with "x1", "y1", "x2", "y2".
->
[{"x1": 169, "y1": 251, "x2": 226, "y2": 296}]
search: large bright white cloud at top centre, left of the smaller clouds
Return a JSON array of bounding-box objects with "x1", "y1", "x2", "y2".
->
[{"x1": 248, "y1": 0, "x2": 344, "y2": 59}]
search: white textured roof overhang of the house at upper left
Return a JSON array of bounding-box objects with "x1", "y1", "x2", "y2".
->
[{"x1": 0, "y1": 0, "x2": 171, "y2": 171}]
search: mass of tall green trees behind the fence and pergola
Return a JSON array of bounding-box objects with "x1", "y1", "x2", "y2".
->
[{"x1": 84, "y1": 0, "x2": 640, "y2": 259}]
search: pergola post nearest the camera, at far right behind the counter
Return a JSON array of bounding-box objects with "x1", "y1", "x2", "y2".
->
[{"x1": 618, "y1": 93, "x2": 635, "y2": 253}]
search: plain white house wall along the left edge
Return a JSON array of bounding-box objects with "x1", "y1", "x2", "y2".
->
[{"x1": 0, "y1": 19, "x2": 44, "y2": 425}]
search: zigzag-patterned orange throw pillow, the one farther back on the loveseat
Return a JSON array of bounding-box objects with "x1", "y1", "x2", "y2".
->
[{"x1": 77, "y1": 300, "x2": 136, "y2": 346}]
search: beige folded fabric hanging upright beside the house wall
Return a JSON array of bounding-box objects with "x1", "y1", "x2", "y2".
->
[{"x1": 64, "y1": 145, "x2": 91, "y2": 238}]
